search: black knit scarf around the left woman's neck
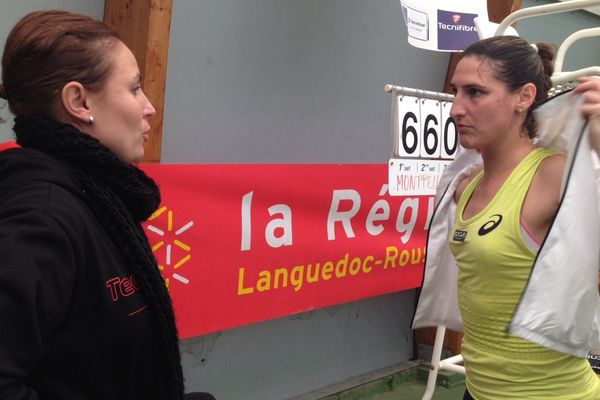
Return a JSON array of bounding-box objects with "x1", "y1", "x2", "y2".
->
[{"x1": 14, "y1": 117, "x2": 183, "y2": 400}]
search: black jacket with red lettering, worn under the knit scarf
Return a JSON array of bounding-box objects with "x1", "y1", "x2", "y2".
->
[{"x1": 0, "y1": 149, "x2": 158, "y2": 400}]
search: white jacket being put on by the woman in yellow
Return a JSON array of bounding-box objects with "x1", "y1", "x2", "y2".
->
[{"x1": 413, "y1": 92, "x2": 600, "y2": 357}]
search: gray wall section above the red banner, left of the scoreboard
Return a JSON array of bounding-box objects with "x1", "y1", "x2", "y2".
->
[{"x1": 162, "y1": 0, "x2": 448, "y2": 163}]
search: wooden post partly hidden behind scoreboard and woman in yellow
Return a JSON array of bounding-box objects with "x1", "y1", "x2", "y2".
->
[{"x1": 414, "y1": 0, "x2": 524, "y2": 355}]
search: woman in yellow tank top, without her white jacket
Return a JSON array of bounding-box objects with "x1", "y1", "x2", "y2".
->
[{"x1": 449, "y1": 36, "x2": 600, "y2": 400}]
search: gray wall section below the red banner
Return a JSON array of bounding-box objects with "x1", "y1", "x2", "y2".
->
[{"x1": 181, "y1": 291, "x2": 415, "y2": 400}]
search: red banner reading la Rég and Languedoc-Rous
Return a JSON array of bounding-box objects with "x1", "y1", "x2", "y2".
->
[{"x1": 142, "y1": 164, "x2": 433, "y2": 338}]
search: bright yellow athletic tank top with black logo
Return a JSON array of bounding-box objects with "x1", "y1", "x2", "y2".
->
[{"x1": 449, "y1": 149, "x2": 600, "y2": 400}]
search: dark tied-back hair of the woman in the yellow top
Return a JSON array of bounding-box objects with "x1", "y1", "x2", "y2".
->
[{"x1": 462, "y1": 36, "x2": 556, "y2": 138}]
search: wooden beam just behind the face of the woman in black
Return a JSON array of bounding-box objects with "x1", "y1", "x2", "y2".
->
[{"x1": 104, "y1": 0, "x2": 173, "y2": 162}]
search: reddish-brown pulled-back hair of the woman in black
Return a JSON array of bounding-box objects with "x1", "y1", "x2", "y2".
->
[{"x1": 0, "y1": 10, "x2": 119, "y2": 117}]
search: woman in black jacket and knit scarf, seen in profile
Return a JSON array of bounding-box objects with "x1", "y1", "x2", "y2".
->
[{"x1": 0, "y1": 11, "x2": 213, "y2": 400}]
